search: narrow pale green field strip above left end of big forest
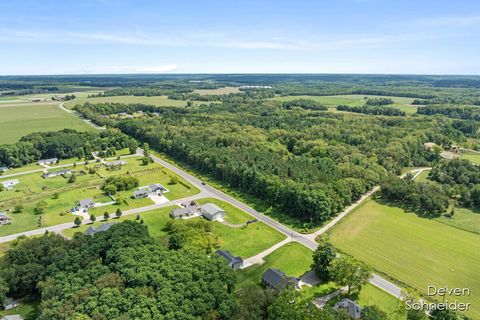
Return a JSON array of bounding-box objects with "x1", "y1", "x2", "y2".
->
[{"x1": 65, "y1": 96, "x2": 194, "y2": 108}]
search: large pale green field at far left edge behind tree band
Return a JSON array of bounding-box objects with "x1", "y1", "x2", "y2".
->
[{"x1": 0, "y1": 103, "x2": 94, "y2": 144}]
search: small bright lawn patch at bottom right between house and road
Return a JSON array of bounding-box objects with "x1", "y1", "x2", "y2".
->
[{"x1": 355, "y1": 284, "x2": 407, "y2": 320}]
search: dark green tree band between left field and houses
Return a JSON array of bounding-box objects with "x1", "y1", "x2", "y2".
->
[{"x1": 0, "y1": 129, "x2": 137, "y2": 168}]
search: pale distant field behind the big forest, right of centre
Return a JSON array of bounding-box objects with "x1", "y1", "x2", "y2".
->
[{"x1": 271, "y1": 94, "x2": 417, "y2": 114}]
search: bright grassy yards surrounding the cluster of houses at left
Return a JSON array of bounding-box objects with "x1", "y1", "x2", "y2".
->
[{"x1": 0, "y1": 157, "x2": 198, "y2": 236}]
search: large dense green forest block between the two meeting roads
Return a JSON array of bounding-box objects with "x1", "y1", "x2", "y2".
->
[{"x1": 76, "y1": 100, "x2": 465, "y2": 224}]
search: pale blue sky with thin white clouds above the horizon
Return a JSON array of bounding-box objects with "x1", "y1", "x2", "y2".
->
[{"x1": 0, "y1": 0, "x2": 480, "y2": 75}]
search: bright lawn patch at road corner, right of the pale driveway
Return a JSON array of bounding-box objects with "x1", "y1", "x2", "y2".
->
[{"x1": 237, "y1": 242, "x2": 313, "y2": 289}]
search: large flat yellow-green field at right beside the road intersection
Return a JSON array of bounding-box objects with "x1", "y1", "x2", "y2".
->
[{"x1": 330, "y1": 199, "x2": 480, "y2": 318}]
